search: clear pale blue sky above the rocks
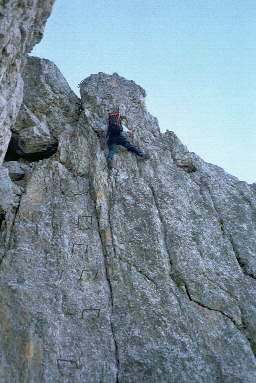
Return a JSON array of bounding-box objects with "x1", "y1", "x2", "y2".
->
[{"x1": 32, "y1": 0, "x2": 256, "y2": 183}]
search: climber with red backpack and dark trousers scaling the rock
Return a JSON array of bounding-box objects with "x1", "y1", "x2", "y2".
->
[{"x1": 99, "y1": 112, "x2": 149, "y2": 168}]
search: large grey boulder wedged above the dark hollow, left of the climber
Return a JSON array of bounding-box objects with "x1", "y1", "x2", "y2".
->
[{"x1": 8, "y1": 57, "x2": 80, "y2": 158}]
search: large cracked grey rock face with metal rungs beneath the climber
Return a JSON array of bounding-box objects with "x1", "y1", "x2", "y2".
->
[{"x1": 0, "y1": 58, "x2": 256, "y2": 383}]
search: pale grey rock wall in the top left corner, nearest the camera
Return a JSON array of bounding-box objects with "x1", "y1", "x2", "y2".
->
[{"x1": 0, "y1": 0, "x2": 54, "y2": 164}]
